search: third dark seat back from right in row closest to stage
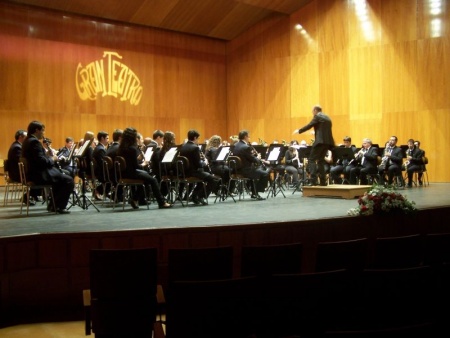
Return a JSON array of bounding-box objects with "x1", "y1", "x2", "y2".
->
[{"x1": 316, "y1": 238, "x2": 368, "y2": 271}]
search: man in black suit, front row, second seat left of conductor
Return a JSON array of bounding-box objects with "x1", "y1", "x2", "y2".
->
[{"x1": 180, "y1": 141, "x2": 218, "y2": 198}]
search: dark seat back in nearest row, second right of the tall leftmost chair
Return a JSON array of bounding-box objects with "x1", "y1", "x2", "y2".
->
[{"x1": 264, "y1": 270, "x2": 355, "y2": 338}]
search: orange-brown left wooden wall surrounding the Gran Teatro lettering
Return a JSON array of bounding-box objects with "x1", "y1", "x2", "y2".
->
[{"x1": 0, "y1": 3, "x2": 226, "y2": 158}]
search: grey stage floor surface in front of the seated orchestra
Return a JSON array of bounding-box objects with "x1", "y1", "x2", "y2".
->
[{"x1": 0, "y1": 183, "x2": 450, "y2": 237}]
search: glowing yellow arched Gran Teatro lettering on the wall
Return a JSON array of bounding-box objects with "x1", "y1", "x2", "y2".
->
[{"x1": 75, "y1": 51, "x2": 143, "y2": 106}]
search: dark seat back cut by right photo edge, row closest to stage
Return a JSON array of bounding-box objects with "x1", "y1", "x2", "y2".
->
[{"x1": 423, "y1": 233, "x2": 450, "y2": 266}]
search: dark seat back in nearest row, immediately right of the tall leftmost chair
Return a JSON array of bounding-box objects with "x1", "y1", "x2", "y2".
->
[{"x1": 166, "y1": 278, "x2": 259, "y2": 338}]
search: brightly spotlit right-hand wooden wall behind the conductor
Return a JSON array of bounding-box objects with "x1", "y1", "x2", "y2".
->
[{"x1": 227, "y1": 0, "x2": 450, "y2": 182}]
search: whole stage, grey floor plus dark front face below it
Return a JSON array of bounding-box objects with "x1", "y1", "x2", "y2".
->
[{"x1": 0, "y1": 183, "x2": 450, "y2": 327}]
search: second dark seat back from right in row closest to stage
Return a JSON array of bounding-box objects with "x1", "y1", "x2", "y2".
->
[{"x1": 371, "y1": 234, "x2": 422, "y2": 269}]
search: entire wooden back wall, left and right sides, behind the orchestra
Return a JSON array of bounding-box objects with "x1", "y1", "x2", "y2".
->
[{"x1": 0, "y1": 0, "x2": 450, "y2": 182}]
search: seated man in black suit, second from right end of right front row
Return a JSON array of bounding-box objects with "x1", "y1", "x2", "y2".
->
[{"x1": 378, "y1": 136, "x2": 403, "y2": 186}]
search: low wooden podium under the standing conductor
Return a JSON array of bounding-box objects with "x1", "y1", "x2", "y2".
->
[{"x1": 303, "y1": 184, "x2": 372, "y2": 199}]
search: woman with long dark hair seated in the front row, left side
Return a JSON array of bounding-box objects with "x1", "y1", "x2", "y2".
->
[{"x1": 117, "y1": 128, "x2": 172, "y2": 209}]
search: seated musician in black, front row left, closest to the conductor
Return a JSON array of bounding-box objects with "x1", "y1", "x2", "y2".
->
[{"x1": 233, "y1": 140, "x2": 269, "y2": 195}]
